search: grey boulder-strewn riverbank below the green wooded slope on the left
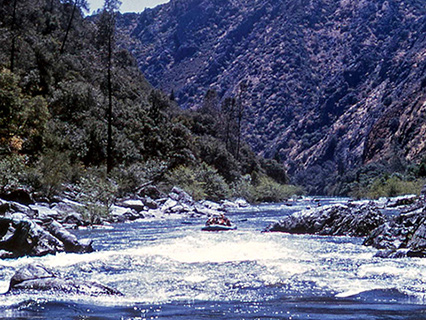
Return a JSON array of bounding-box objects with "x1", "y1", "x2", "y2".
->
[{"x1": 0, "y1": 187, "x2": 247, "y2": 259}]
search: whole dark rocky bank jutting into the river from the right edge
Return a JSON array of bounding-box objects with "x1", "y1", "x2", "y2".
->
[{"x1": 265, "y1": 196, "x2": 426, "y2": 258}]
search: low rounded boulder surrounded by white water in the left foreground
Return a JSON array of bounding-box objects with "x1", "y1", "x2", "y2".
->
[{"x1": 6, "y1": 264, "x2": 122, "y2": 296}]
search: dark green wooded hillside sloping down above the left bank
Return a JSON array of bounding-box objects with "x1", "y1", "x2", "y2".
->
[{"x1": 0, "y1": 0, "x2": 296, "y2": 201}]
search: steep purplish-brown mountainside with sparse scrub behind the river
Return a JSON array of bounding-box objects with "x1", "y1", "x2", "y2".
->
[{"x1": 115, "y1": 0, "x2": 426, "y2": 193}]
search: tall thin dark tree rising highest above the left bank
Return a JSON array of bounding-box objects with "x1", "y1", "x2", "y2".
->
[{"x1": 98, "y1": 0, "x2": 121, "y2": 173}]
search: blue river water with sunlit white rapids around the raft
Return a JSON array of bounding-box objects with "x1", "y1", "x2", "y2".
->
[{"x1": 0, "y1": 199, "x2": 426, "y2": 320}]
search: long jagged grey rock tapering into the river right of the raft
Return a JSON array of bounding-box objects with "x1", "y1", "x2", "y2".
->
[{"x1": 265, "y1": 204, "x2": 385, "y2": 237}]
